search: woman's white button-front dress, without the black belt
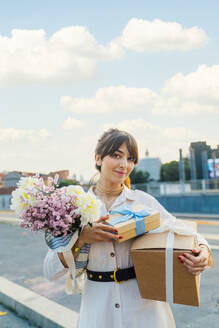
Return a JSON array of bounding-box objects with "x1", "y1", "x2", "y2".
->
[{"x1": 44, "y1": 187, "x2": 207, "y2": 328}]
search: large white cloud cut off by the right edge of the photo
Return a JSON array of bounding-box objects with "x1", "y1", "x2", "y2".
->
[{"x1": 154, "y1": 65, "x2": 219, "y2": 115}]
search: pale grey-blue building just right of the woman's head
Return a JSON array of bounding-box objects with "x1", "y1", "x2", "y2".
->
[{"x1": 135, "y1": 150, "x2": 161, "y2": 181}]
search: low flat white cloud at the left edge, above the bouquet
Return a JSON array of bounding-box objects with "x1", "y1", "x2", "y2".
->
[{"x1": 0, "y1": 128, "x2": 50, "y2": 141}]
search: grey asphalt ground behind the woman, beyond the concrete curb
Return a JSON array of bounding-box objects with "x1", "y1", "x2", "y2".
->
[{"x1": 0, "y1": 215, "x2": 219, "y2": 328}]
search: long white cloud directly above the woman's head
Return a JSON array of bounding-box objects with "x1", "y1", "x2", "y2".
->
[{"x1": 60, "y1": 85, "x2": 157, "y2": 113}]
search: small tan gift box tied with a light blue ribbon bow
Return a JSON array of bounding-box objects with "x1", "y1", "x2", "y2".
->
[{"x1": 107, "y1": 204, "x2": 160, "y2": 243}]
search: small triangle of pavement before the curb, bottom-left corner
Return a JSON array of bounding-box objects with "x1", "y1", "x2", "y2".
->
[{"x1": 0, "y1": 304, "x2": 37, "y2": 328}]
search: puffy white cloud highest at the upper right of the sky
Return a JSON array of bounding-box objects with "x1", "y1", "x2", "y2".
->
[{"x1": 114, "y1": 18, "x2": 208, "y2": 52}]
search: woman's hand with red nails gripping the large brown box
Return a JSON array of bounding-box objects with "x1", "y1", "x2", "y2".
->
[{"x1": 178, "y1": 245, "x2": 210, "y2": 276}]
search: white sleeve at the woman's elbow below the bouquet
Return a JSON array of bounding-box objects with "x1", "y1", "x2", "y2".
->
[{"x1": 43, "y1": 249, "x2": 68, "y2": 280}]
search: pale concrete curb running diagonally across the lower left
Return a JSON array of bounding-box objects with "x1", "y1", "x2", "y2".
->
[{"x1": 0, "y1": 277, "x2": 78, "y2": 328}]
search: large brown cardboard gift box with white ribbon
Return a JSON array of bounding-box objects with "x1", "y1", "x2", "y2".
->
[{"x1": 131, "y1": 220, "x2": 200, "y2": 306}]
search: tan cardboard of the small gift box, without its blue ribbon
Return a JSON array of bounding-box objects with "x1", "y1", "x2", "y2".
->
[{"x1": 107, "y1": 204, "x2": 160, "y2": 243}]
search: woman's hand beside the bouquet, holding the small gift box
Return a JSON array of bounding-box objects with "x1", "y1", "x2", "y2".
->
[{"x1": 78, "y1": 215, "x2": 122, "y2": 244}]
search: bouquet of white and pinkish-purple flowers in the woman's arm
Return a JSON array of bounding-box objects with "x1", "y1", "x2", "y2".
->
[{"x1": 11, "y1": 175, "x2": 100, "y2": 237}]
